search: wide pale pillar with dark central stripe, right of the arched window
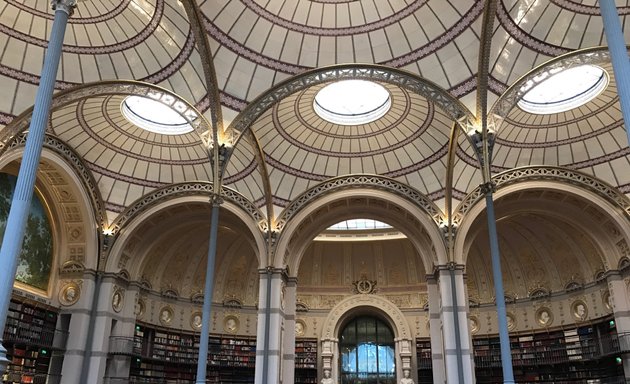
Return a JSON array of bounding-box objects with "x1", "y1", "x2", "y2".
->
[{"x1": 438, "y1": 265, "x2": 474, "y2": 384}]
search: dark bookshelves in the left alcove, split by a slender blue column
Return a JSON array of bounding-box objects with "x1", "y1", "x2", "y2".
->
[{"x1": 130, "y1": 324, "x2": 256, "y2": 384}]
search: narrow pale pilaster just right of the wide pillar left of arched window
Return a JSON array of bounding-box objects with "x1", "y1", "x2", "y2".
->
[{"x1": 282, "y1": 278, "x2": 297, "y2": 383}]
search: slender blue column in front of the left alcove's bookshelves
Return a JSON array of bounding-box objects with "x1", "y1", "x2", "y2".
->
[{"x1": 195, "y1": 200, "x2": 221, "y2": 384}]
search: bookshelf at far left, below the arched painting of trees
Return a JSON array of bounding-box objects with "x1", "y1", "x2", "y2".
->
[{"x1": 2, "y1": 300, "x2": 58, "y2": 384}]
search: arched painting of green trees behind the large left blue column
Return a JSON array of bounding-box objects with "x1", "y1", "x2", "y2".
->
[{"x1": 0, "y1": 173, "x2": 52, "y2": 290}]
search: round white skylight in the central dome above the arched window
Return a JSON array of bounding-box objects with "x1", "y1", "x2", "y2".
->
[{"x1": 313, "y1": 80, "x2": 392, "y2": 125}]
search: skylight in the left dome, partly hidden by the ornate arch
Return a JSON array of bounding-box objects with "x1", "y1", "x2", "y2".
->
[{"x1": 121, "y1": 96, "x2": 193, "y2": 135}]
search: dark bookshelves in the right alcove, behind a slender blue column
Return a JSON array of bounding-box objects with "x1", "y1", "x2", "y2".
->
[{"x1": 473, "y1": 320, "x2": 623, "y2": 384}]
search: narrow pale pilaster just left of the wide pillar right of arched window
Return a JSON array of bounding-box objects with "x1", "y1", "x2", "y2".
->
[{"x1": 427, "y1": 276, "x2": 446, "y2": 383}]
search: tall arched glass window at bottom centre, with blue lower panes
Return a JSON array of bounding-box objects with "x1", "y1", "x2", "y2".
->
[{"x1": 339, "y1": 316, "x2": 396, "y2": 384}]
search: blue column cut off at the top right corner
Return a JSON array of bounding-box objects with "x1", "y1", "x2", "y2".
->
[{"x1": 599, "y1": 0, "x2": 630, "y2": 143}]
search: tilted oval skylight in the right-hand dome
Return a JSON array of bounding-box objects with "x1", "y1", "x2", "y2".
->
[{"x1": 518, "y1": 65, "x2": 608, "y2": 114}]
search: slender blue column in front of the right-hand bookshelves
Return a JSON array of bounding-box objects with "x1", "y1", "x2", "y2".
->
[{"x1": 483, "y1": 183, "x2": 514, "y2": 384}]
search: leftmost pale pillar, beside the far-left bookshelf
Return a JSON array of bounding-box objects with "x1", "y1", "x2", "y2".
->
[{"x1": 60, "y1": 274, "x2": 96, "y2": 384}]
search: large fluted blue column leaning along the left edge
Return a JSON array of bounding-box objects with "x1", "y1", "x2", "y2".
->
[{"x1": 0, "y1": 0, "x2": 76, "y2": 375}]
